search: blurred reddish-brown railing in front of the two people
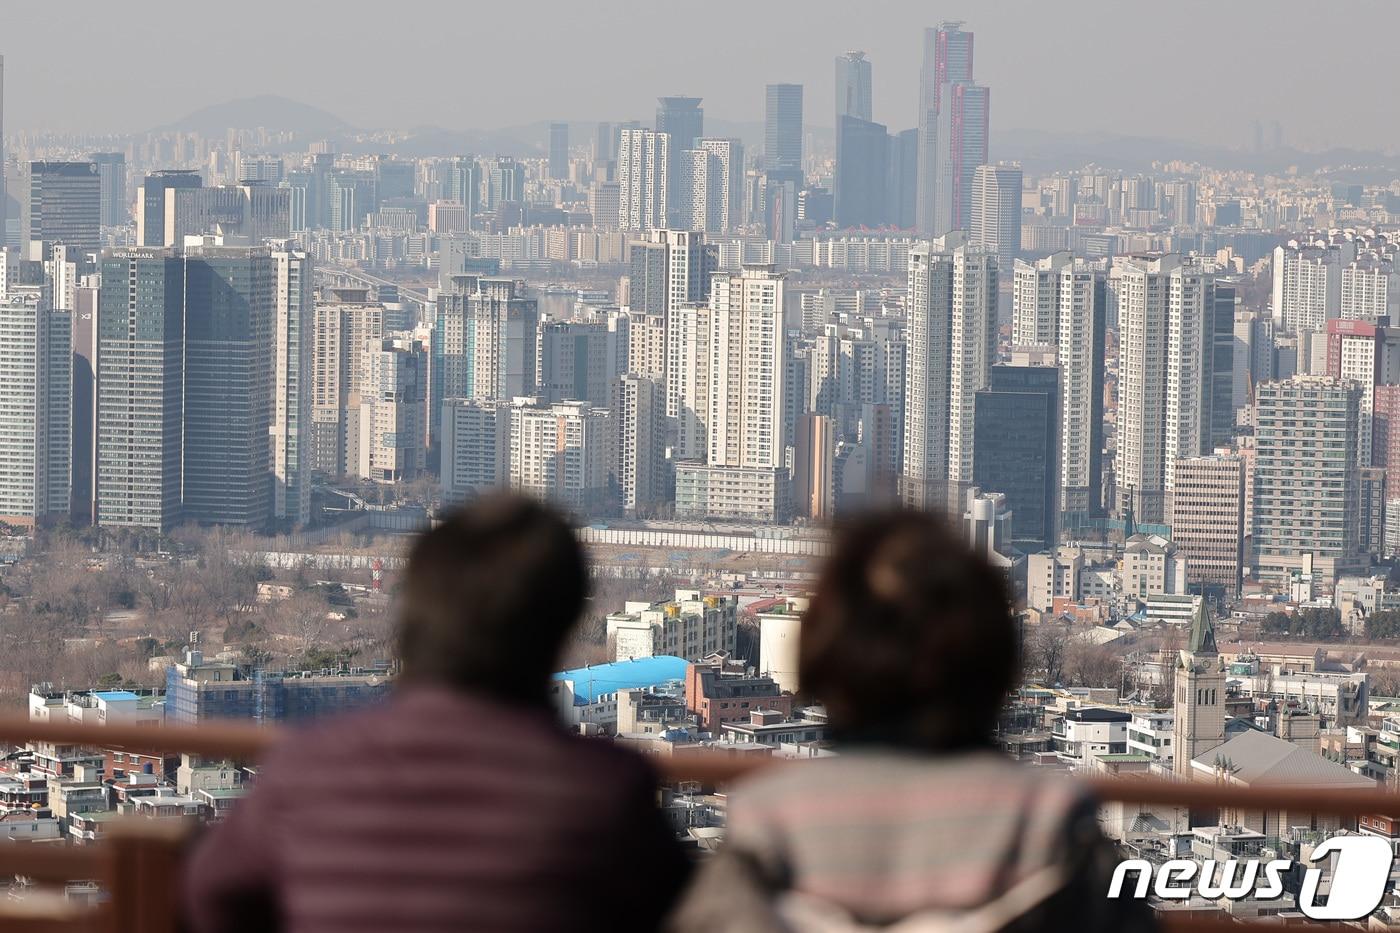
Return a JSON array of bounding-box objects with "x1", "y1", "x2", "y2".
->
[{"x1": 0, "y1": 717, "x2": 1400, "y2": 933}]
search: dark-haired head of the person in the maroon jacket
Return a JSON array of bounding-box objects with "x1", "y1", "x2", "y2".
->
[{"x1": 399, "y1": 493, "x2": 588, "y2": 702}]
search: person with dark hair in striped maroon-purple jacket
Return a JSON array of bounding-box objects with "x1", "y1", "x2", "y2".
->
[{"x1": 182, "y1": 496, "x2": 687, "y2": 933}]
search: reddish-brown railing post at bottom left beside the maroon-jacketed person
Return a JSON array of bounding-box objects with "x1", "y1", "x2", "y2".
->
[{"x1": 105, "y1": 820, "x2": 185, "y2": 933}]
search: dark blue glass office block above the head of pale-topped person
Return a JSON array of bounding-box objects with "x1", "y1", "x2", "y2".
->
[{"x1": 973, "y1": 364, "x2": 1060, "y2": 553}]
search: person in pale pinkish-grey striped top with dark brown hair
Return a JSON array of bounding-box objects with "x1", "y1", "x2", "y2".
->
[{"x1": 672, "y1": 511, "x2": 1152, "y2": 933}]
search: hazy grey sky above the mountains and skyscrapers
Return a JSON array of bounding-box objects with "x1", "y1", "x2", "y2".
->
[{"x1": 0, "y1": 0, "x2": 1400, "y2": 148}]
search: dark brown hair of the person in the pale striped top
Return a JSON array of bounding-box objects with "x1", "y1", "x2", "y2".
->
[{"x1": 798, "y1": 510, "x2": 1016, "y2": 749}]
